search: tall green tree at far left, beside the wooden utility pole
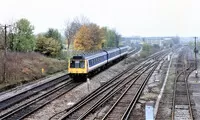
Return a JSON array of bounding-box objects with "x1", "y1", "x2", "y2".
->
[{"x1": 11, "y1": 18, "x2": 35, "y2": 52}]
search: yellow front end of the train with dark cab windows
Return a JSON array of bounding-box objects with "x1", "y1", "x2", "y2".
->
[{"x1": 68, "y1": 58, "x2": 87, "y2": 81}]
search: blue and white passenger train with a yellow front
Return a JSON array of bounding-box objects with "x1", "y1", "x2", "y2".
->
[{"x1": 68, "y1": 46, "x2": 129, "y2": 80}]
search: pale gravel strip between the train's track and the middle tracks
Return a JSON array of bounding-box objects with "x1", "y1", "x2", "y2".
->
[{"x1": 25, "y1": 60, "x2": 134, "y2": 120}]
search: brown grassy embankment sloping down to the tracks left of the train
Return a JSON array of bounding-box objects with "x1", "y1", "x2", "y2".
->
[{"x1": 0, "y1": 51, "x2": 67, "y2": 91}]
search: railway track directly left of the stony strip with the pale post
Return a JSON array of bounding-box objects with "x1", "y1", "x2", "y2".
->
[{"x1": 102, "y1": 65, "x2": 157, "y2": 120}]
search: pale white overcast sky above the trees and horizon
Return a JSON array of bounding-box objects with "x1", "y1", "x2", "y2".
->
[{"x1": 0, "y1": 0, "x2": 200, "y2": 37}]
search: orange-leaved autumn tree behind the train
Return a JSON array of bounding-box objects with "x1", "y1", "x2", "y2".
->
[{"x1": 74, "y1": 25, "x2": 94, "y2": 51}]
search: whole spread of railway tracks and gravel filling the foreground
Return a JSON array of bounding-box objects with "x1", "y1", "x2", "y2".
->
[{"x1": 0, "y1": 46, "x2": 200, "y2": 120}]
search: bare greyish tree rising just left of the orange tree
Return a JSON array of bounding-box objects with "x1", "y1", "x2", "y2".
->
[{"x1": 65, "y1": 16, "x2": 89, "y2": 49}]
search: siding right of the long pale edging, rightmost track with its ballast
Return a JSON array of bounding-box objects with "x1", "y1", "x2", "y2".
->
[{"x1": 156, "y1": 47, "x2": 194, "y2": 120}]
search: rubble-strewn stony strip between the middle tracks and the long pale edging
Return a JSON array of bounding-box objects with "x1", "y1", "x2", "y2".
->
[{"x1": 130, "y1": 54, "x2": 169, "y2": 120}]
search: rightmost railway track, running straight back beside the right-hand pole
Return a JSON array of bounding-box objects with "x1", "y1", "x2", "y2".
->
[{"x1": 171, "y1": 47, "x2": 194, "y2": 120}]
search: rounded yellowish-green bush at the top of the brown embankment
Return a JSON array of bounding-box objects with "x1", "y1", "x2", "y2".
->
[{"x1": 36, "y1": 35, "x2": 61, "y2": 57}]
